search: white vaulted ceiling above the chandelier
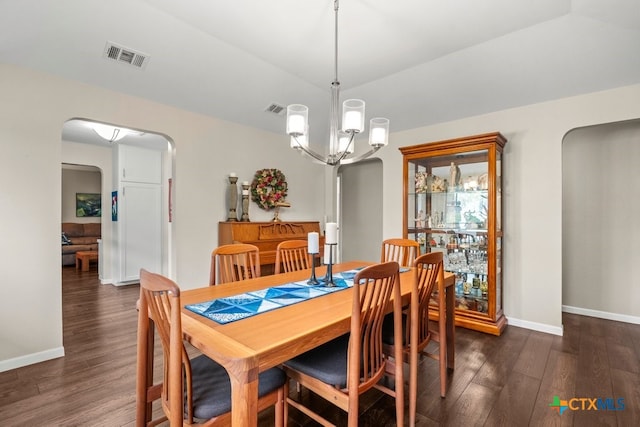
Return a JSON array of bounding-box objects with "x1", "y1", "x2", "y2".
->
[{"x1": 0, "y1": 0, "x2": 640, "y2": 145}]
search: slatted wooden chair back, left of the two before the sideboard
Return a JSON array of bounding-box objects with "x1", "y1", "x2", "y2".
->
[{"x1": 209, "y1": 243, "x2": 260, "y2": 286}]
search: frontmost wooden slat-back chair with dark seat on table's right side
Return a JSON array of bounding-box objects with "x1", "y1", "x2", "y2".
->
[{"x1": 283, "y1": 262, "x2": 404, "y2": 427}]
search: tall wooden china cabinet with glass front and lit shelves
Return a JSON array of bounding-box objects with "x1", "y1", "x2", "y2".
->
[{"x1": 400, "y1": 133, "x2": 507, "y2": 335}]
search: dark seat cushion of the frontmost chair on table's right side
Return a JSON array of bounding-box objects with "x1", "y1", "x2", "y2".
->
[{"x1": 285, "y1": 334, "x2": 350, "y2": 387}]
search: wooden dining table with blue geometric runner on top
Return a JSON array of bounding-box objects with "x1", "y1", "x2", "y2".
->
[{"x1": 143, "y1": 261, "x2": 454, "y2": 427}]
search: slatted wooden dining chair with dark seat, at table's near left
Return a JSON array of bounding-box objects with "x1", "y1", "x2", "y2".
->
[{"x1": 136, "y1": 269, "x2": 288, "y2": 426}]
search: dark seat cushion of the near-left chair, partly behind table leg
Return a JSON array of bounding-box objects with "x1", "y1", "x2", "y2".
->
[{"x1": 185, "y1": 355, "x2": 287, "y2": 420}]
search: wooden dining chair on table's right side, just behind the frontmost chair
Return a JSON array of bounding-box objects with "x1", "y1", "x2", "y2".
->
[{"x1": 382, "y1": 252, "x2": 446, "y2": 425}]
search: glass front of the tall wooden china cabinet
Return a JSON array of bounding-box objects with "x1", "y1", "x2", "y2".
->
[{"x1": 408, "y1": 150, "x2": 489, "y2": 313}]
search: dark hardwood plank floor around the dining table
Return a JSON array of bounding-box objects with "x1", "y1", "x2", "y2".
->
[{"x1": 0, "y1": 267, "x2": 640, "y2": 427}]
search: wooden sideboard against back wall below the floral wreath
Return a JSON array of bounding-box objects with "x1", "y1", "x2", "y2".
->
[{"x1": 218, "y1": 221, "x2": 324, "y2": 276}]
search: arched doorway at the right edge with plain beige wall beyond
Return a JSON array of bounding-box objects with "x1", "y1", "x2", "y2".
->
[{"x1": 562, "y1": 120, "x2": 640, "y2": 323}]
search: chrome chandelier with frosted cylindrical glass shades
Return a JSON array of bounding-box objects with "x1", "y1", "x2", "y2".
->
[{"x1": 287, "y1": 0, "x2": 389, "y2": 166}]
